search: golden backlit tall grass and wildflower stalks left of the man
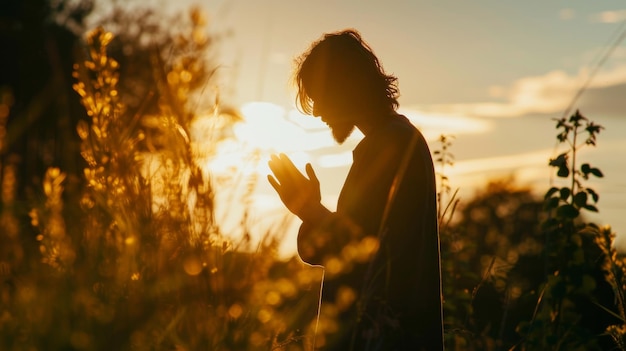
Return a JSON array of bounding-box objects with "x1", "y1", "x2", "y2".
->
[{"x1": 0, "y1": 17, "x2": 319, "y2": 350}]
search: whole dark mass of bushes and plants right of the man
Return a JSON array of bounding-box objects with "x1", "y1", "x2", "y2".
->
[{"x1": 434, "y1": 119, "x2": 626, "y2": 350}]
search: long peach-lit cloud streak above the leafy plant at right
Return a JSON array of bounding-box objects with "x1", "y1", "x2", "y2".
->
[{"x1": 419, "y1": 64, "x2": 626, "y2": 117}]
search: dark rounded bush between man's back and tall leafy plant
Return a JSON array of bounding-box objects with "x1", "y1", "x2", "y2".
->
[{"x1": 441, "y1": 179, "x2": 543, "y2": 350}]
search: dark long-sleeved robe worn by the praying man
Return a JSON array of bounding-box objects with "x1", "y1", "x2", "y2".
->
[{"x1": 298, "y1": 114, "x2": 443, "y2": 351}]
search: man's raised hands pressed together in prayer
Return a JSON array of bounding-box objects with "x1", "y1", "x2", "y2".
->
[{"x1": 267, "y1": 154, "x2": 322, "y2": 220}]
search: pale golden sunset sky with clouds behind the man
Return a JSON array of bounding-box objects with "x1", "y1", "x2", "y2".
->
[{"x1": 107, "y1": 0, "x2": 626, "y2": 253}]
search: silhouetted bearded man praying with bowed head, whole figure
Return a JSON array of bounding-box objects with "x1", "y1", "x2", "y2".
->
[{"x1": 268, "y1": 30, "x2": 443, "y2": 351}]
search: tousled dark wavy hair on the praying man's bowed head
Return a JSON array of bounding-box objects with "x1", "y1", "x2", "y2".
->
[{"x1": 294, "y1": 29, "x2": 399, "y2": 114}]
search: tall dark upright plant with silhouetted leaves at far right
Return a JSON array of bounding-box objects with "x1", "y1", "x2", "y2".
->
[{"x1": 519, "y1": 111, "x2": 606, "y2": 350}]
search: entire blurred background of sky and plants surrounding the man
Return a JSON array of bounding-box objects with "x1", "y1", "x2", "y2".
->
[{"x1": 0, "y1": 0, "x2": 626, "y2": 351}]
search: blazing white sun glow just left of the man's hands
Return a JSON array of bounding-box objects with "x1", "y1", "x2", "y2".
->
[{"x1": 192, "y1": 102, "x2": 334, "y2": 257}]
